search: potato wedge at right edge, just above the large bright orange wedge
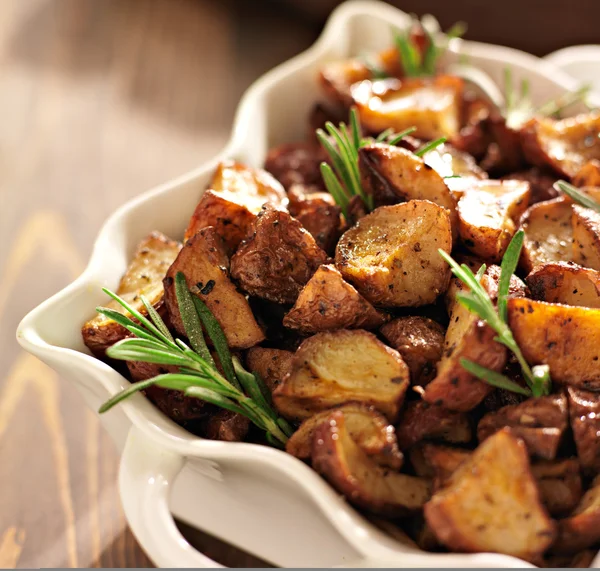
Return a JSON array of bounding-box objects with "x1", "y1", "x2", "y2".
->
[{"x1": 527, "y1": 262, "x2": 600, "y2": 309}]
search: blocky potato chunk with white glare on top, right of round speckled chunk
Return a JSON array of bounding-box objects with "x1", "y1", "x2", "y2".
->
[{"x1": 458, "y1": 180, "x2": 529, "y2": 262}]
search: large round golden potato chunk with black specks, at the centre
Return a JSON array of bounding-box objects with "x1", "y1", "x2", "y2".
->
[{"x1": 335, "y1": 200, "x2": 452, "y2": 307}]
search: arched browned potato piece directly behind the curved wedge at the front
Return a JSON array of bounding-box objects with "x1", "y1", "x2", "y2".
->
[{"x1": 285, "y1": 403, "x2": 404, "y2": 470}]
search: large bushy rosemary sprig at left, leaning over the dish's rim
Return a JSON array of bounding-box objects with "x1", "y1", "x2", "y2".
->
[{"x1": 96, "y1": 272, "x2": 293, "y2": 447}]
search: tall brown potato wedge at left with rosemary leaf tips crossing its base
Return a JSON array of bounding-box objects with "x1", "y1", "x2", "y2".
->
[{"x1": 163, "y1": 226, "x2": 265, "y2": 349}]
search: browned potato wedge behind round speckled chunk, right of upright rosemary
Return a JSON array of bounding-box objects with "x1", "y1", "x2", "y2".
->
[{"x1": 358, "y1": 143, "x2": 458, "y2": 228}]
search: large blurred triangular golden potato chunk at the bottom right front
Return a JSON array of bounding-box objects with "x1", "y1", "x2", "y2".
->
[{"x1": 425, "y1": 430, "x2": 555, "y2": 560}]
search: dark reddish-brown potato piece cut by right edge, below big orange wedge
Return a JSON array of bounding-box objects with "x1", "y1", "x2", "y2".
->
[{"x1": 567, "y1": 387, "x2": 600, "y2": 475}]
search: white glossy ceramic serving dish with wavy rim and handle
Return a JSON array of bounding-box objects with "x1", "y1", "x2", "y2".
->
[{"x1": 17, "y1": 1, "x2": 600, "y2": 568}]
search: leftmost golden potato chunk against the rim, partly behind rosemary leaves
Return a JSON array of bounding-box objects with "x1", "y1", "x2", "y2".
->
[{"x1": 81, "y1": 232, "x2": 181, "y2": 358}]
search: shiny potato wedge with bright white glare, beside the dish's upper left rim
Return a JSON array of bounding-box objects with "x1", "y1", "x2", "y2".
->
[{"x1": 185, "y1": 161, "x2": 288, "y2": 252}]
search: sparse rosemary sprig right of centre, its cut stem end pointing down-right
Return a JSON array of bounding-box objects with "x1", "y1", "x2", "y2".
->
[{"x1": 438, "y1": 230, "x2": 551, "y2": 397}]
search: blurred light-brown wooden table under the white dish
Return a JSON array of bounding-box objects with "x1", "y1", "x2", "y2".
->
[{"x1": 0, "y1": 0, "x2": 315, "y2": 567}]
